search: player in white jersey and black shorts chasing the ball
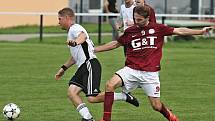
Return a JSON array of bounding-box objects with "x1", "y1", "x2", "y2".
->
[{"x1": 55, "y1": 8, "x2": 139, "y2": 121}]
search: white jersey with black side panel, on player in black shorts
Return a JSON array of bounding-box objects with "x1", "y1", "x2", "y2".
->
[{"x1": 67, "y1": 24, "x2": 96, "y2": 67}]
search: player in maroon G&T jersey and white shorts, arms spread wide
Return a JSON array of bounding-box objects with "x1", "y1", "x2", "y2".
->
[{"x1": 95, "y1": 5, "x2": 211, "y2": 121}]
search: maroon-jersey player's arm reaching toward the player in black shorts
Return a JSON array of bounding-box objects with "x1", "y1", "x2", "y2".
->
[{"x1": 94, "y1": 41, "x2": 121, "y2": 53}]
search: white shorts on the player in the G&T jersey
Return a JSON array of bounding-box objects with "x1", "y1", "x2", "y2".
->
[{"x1": 116, "y1": 67, "x2": 160, "y2": 97}]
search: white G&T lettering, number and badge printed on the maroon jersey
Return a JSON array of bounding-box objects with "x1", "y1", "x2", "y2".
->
[{"x1": 131, "y1": 29, "x2": 157, "y2": 50}]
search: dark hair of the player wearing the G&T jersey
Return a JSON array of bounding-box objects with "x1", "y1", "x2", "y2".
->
[{"x1": 134, "y1": 5, "x2": 150, "y2": 18}]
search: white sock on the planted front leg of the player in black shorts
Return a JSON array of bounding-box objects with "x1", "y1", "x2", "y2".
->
[{"x1": 76, "y1": 103, "x2": 93, "y2": 119}]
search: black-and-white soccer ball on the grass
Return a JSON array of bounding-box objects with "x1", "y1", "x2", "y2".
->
[{"x1": 3, "y1": 103, "x2": 20, "y2": 120}]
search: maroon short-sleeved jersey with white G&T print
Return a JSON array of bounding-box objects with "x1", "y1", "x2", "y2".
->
[{"x1": 118, "y1": 23, "x2": 174, "y2": 72}]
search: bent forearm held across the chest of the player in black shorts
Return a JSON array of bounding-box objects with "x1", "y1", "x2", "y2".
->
[{"x1": 67, "y1": 32, "x2": 87, "y2": 47}]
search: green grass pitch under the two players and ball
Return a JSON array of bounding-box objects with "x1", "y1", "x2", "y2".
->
[{"x1": 0, "y1": 37, "x2": 215, "y2": 121}]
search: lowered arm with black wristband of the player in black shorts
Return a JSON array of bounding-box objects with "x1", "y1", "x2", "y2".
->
[{"x1": 55, "y1": 57, "x2": 75, "y2": 80}]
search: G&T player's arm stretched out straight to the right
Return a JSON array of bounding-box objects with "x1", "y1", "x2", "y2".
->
[{"x1": 173, "y1": 27, "x2": 212, "y2": 35}]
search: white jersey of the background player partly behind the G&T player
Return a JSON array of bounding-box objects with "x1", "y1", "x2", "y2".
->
[{"x1": 120, "y1": 4, "x2": 135, "y2": 30}]
